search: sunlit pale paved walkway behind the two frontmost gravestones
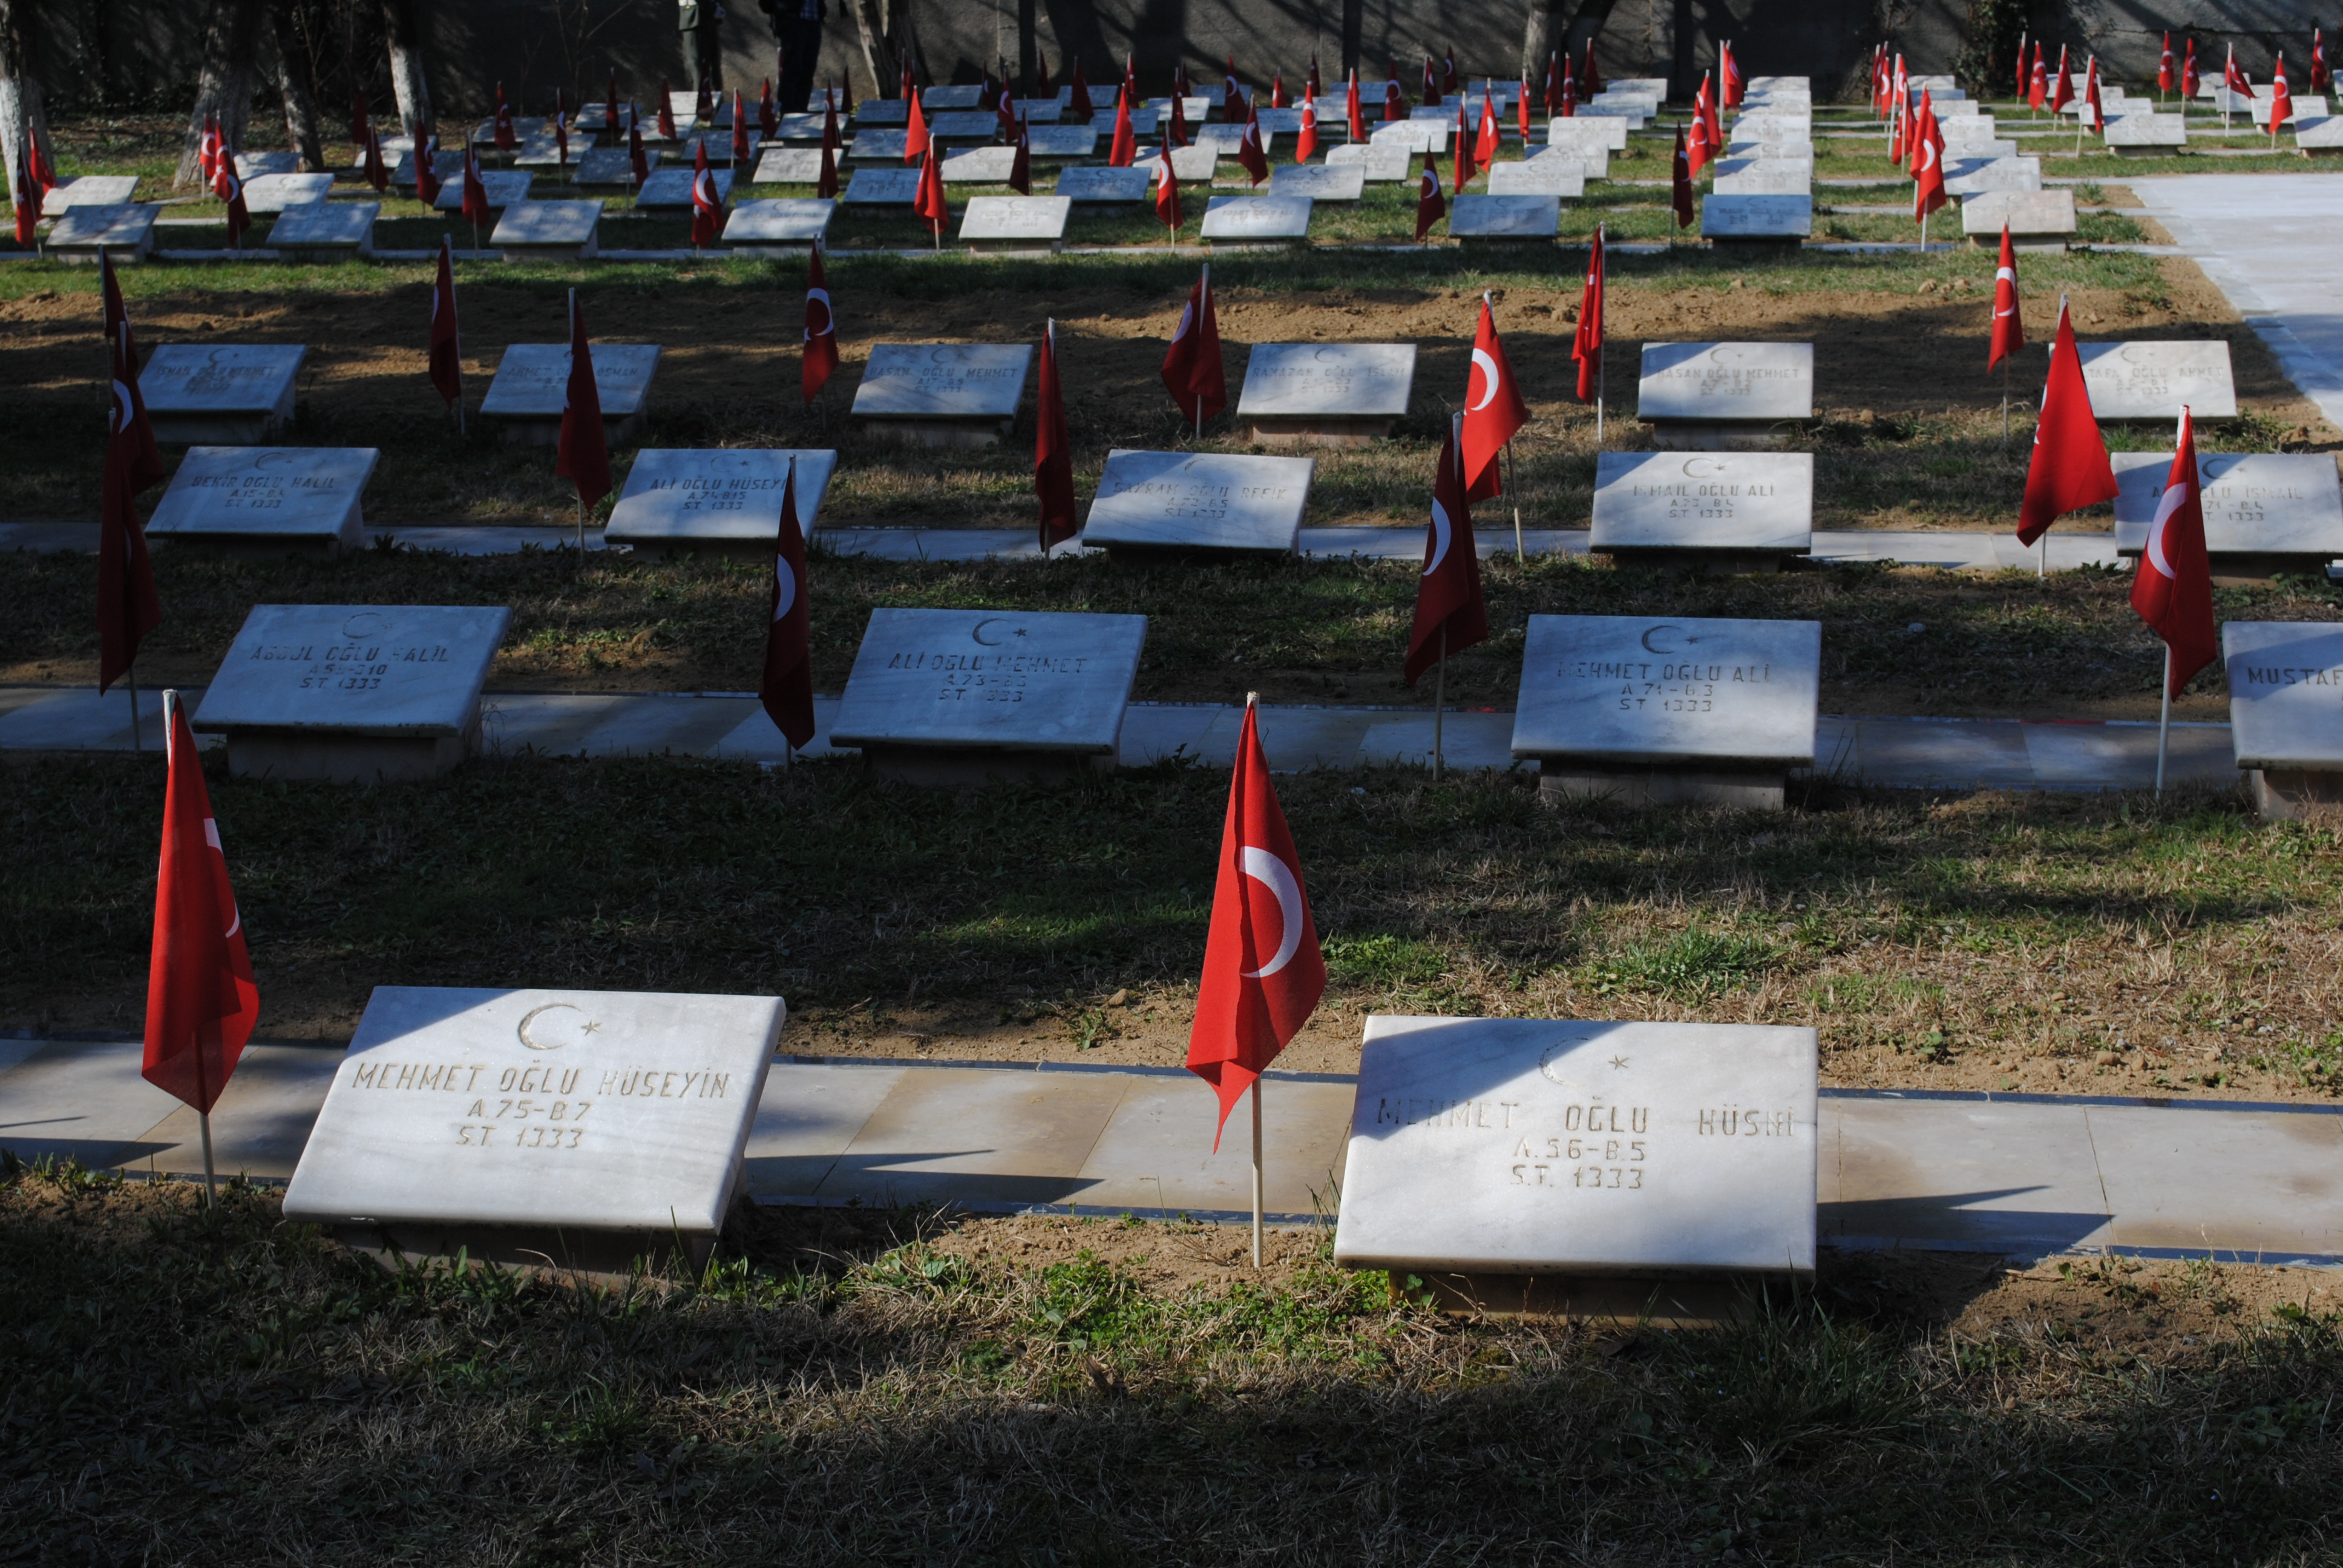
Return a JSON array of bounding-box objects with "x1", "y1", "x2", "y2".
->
[{"x1": 0, "y1": 1040, "x2": 2343, "y2": 1266}]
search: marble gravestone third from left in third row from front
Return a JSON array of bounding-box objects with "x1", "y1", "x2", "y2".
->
[{"x1": 1083, "y1": 448, "x2": 1317, "y2": 555}]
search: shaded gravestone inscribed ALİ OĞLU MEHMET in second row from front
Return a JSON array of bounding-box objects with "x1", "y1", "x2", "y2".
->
[{"x1": 830, "y1": 609, "x2": 1148, "y2": 785}]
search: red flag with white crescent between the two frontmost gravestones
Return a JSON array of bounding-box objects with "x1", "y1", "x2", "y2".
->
[{"x1": 1188, "y1": 705, "x2": 1326, "y2": 1151}]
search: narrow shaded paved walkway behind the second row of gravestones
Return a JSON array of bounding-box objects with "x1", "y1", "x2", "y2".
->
[{"x1": 0, "y1": 687, "x2": 2238, "y2": 792}]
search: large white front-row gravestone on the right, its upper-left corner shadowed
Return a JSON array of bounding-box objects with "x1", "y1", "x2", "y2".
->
[{"x1": 1333, "y1": 1015, "x2": 1821, "y2": 1275}]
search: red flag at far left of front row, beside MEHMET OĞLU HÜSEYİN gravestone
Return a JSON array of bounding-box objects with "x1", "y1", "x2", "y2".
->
[{"x1": 138, "y1": 703, "x2": 260, "y2": 1116}]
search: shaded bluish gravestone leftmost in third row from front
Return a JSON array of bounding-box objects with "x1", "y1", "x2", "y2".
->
[{"x1": 148, "y1": 445, "x2": 382, "y2": 549}]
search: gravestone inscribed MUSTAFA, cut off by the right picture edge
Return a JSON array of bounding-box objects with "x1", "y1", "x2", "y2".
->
[{"x1": 2221, "y1": 618, "x2": 2343, "y2": 818}]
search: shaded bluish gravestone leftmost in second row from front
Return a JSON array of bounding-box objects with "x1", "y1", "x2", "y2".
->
[{"x1": 190, "y1": 605, "x2": 513, "y2": 738}]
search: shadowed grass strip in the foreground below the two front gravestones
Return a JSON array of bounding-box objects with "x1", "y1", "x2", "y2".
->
[{"x1": 0, "y1": 1167, "x2": 2343, "y2": 1568}]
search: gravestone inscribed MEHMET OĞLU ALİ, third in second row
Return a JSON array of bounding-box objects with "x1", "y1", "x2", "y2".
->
[{"x1": 1513, "y1": 614, "x2": 1823, "y2": 809}]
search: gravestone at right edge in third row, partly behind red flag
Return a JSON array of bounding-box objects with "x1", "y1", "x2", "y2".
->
[{"x1": 2109, "y1": 452, "x2": 2343, "y2": 579}]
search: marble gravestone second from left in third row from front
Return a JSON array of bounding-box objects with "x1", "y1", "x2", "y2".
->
[{"x1": 605, "y1": 448, "x2": 839, "y2": 560}]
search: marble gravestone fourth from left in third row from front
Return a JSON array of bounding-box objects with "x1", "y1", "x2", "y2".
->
[{"x1": 1588, "y1": 452, "x2": 1814, "y2": 572}]
